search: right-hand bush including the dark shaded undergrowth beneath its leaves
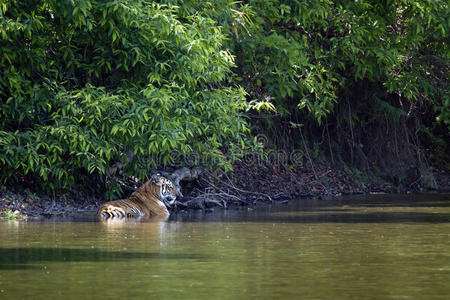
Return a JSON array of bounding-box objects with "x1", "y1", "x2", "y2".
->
[{"x1": 181, "y1": 0, "x2": 450, "y2": 177}]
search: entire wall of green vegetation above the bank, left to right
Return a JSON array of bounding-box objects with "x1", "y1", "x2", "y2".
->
[{"x1": 0, "y1": 0, "x2": 450, "y2": 198}]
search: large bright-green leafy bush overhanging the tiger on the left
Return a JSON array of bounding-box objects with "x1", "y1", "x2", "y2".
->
[{"x1": 0, "y1": 0, "x2": 248, "y2": 196}]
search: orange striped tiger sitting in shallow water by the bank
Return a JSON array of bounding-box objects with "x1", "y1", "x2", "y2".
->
[{"x1": 97, "y1": 173, "x2": 182, "y2": 219}]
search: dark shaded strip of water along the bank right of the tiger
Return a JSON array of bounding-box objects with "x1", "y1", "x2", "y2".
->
[{"x1": 170, "y1": 194, "x2": 450, "y2": 223}]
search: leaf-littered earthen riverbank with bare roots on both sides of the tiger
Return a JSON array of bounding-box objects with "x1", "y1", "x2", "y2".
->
[{"x1": 0, "y1": 163, "x2": 450, "y2": 219}]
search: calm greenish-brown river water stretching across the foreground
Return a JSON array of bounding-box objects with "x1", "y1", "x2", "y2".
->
[{"x1": 0, "y1": 194, "x2": 450, "y2": 299}]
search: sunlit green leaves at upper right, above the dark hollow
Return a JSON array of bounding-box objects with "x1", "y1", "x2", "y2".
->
[{"x1": 208, "y1": 0, "x2": 450, "y2": 122}]
